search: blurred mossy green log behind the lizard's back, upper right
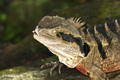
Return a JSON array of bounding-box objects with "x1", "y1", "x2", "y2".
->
[{"x1": 52, "y1": 1, "x2": 120, "y2": 26}]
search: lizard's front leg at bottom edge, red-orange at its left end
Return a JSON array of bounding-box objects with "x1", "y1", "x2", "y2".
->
[{"x1": 76, "y1": 64, "x2": 109, "y2": 80}]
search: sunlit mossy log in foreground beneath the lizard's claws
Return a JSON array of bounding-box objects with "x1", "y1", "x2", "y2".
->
[{"x1": 0, "y1": 56, "x2": 120, "y2": 80}]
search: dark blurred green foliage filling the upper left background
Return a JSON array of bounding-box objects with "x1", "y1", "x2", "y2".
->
[{"x1": 0, "y1": 0, "x2": 80, "y2": 44}]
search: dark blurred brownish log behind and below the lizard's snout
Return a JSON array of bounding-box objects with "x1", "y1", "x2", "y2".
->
[{"x1": 0, "y1": 35, "x2": 52, "y2": 69}]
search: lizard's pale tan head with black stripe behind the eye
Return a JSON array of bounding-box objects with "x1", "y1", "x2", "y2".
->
[{"x1": 33, "y1": 16, "x2": 84, "y2": 68}]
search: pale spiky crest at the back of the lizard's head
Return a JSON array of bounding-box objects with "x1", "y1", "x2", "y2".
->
[{"x1": 67, "y1": 17, "x2": 85, "y2": 31}]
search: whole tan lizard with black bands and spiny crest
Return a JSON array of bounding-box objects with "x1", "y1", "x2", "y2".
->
[{"x1": 33, "y1": 16, "x2": 120, "y2": 80}]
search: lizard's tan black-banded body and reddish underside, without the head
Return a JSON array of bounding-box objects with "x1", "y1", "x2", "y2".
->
[{"x1": 72, "y1": 19, "x2": 120, "y2": 80}]
